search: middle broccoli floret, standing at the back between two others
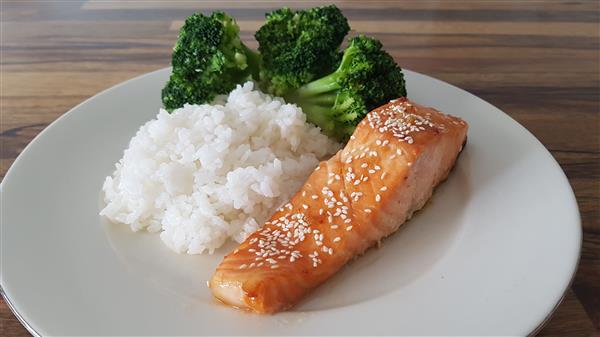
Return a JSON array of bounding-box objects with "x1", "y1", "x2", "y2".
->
[{"x1": 255, "y1": 5, "x2": 350, "y2": 96}]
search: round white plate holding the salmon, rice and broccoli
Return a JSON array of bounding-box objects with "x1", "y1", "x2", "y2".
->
[{"x1": 1, "y1": 69, "x2": 581, "y2": 335}]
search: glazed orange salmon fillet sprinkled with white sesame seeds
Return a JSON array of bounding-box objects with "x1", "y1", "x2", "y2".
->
[{"x1": 209, "y1": 98, "x2": 468, "y2": 313}]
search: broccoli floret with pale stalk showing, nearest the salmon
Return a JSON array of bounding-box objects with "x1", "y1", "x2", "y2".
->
[{"x1": 284, "y1": 36, "x2": 406, "y2": 141}]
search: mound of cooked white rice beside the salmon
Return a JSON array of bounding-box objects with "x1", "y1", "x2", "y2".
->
[{"x1": 100, "y1": 82, "x2": 340, "y2": 254}]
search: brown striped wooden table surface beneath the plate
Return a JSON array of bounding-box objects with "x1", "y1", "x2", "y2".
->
[{"x1": 0, "y1": 0, "x2": 600, "y2": 337}]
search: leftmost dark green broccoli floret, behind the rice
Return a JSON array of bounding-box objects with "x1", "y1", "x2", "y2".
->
[{"x1": 162, "y1": 12, "x2": 260, "y2": 111}]
